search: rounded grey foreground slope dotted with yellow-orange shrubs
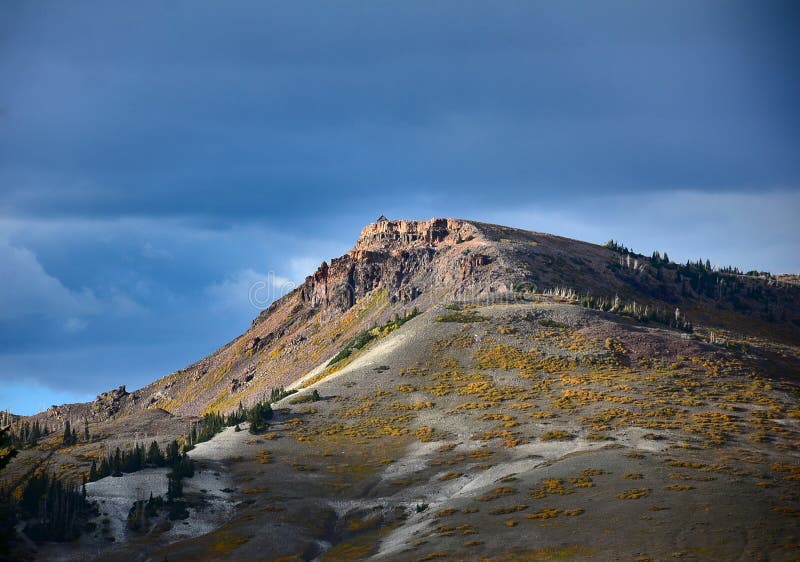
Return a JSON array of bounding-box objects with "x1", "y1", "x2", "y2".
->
[{"x1": 83, "y1": 303, "x2": 800, "y2": 560}]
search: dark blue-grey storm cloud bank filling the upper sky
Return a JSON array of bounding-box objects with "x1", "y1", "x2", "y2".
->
[{"x1": 0, "y1": 2, "x2": 800, "y2": 218}]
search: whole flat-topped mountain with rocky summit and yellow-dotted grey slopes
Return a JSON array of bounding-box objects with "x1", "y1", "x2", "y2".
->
[{"x1": 1, "y1": 217, "x2": 800, "y2": 560}]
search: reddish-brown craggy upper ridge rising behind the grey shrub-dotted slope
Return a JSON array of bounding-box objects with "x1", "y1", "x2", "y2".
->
[{"x1": 76, "y1": 218, "x2": 800, "y2": 414}]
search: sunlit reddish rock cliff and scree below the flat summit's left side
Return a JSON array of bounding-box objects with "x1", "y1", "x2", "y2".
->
[{"x1": 104, "y1": 219, "x2": 513, "y2": 414}]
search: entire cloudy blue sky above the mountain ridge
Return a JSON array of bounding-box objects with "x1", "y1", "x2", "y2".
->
[{"x1": 0, "y1": 0, "x2": 800, "y2": 414}]
